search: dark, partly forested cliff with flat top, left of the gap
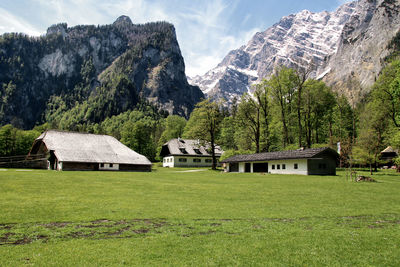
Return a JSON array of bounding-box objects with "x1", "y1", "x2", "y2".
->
[{"x1": 0, "y1": 16, "x2": 203, "y2": 128}]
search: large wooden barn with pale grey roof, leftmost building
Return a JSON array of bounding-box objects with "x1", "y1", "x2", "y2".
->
[{"x1": 29, "y1": 130, "x2": 151, "y2": 171}]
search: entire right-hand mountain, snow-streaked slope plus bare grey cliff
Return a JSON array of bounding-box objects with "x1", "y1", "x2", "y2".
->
[{"x1": 191, "y1": 0, "x2": 400, "y2": 102}]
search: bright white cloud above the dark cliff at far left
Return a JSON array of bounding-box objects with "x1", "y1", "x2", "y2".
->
[{"x1": 0, "y1": 8, "x2": 41, "y2": 36}]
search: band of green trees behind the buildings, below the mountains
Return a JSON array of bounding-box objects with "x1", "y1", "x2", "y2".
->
[{"x1": 0, "y1": 60, "x2": 400, "y2": 172}]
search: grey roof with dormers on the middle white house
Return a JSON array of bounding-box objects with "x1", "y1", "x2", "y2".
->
[{"x1": 160, "y1": 138, "x2": 223, "y2": 157}]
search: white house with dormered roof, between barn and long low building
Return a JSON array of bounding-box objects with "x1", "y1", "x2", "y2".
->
[{"x1": 160, "y1": 138, "x2": 223, "y2": 168}]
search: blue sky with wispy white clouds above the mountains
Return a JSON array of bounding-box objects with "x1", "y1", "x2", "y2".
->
[{"x1": 0, "y1": 0, "x2": 349, "y2": 76}]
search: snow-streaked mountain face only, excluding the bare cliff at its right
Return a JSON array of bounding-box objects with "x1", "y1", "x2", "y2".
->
[{"x1": 191, "y1": 3, "x2": 356, "y2": 101}]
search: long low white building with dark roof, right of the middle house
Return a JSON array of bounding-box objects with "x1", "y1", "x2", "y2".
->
[{"x1": 221, "y1": 147, "x2": 339, "y2": 175}]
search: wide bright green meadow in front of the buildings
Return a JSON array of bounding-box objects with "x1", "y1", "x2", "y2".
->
[{"x1": 0, "y1": 168, "x2": 400, "y2": 266}]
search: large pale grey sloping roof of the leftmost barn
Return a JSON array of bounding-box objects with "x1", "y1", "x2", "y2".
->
[{"x1": 31, "y1": 130, "x2": 151, "y2": 165}]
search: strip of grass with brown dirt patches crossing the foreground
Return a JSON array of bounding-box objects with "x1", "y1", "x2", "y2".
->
[{"x1": 0, "y1": 214, "x2": 400, "y2": 245}]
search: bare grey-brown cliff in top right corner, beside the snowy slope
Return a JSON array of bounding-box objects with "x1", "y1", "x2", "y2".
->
[{"x1": 321, "y1": 0, "x2": 400, "y2": 102}]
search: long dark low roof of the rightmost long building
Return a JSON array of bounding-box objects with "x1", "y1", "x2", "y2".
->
[{"x1": 221, "y1": 147, "x2": 339, "y2": 163}]
